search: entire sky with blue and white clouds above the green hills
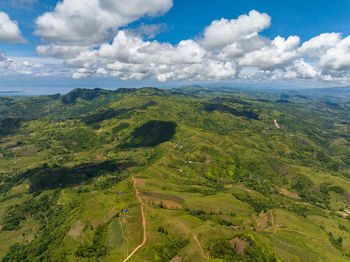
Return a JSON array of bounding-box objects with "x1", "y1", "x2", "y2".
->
[{"x1": 0, "y1": 0, "x2": 350, "y2": 93}]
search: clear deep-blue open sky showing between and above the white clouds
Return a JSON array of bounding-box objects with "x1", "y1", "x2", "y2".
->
[{"x1": 0, "y1": 0, "x2": 350, "y2": 56}]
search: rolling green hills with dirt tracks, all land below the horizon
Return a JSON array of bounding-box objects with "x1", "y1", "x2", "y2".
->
[{"x1": 0, "y1": 87, "x2": 350, "y2": 262}]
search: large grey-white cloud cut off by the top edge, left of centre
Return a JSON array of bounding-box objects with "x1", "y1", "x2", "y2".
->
[{"x1": 35, "y1": 0, "x2": 172, "y2": 45}]
